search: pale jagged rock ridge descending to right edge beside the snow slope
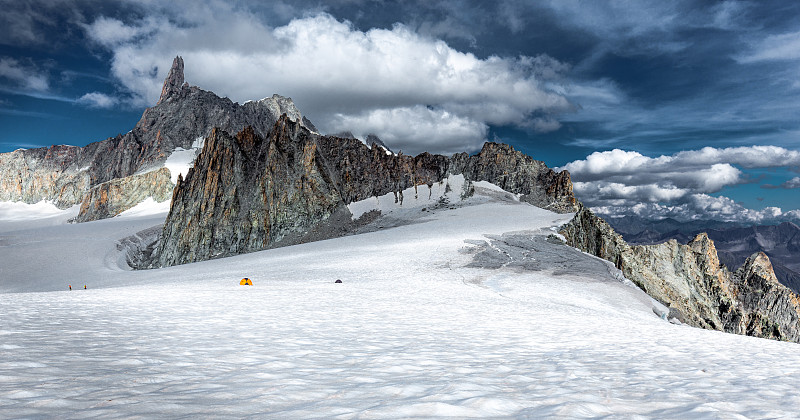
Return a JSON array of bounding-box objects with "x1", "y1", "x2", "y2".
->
[{"x1": 561, "y1": 207, "x2": 800, "y2": 342}]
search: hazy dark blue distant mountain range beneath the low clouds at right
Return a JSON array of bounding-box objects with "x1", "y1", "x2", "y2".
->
[{"x1": 604, "y1": 215, "x2": 800, "y2": 293}]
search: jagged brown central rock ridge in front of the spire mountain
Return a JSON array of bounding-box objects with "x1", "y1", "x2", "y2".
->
[{"x1": 154, "y1": 120, "x2": 575, "y2": 266}]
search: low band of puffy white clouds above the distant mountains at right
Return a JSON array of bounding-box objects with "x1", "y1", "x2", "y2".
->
[{"x1": 559, "y1": 146, "x2": 800, "y2": 223}]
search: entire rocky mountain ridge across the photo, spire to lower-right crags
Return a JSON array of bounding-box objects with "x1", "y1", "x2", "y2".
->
[{"x1": 0, "y1": 57, "x2": 800, "y2": 341}]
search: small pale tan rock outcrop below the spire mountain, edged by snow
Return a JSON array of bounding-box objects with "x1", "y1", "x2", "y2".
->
[{"x1": 75, "y1": 168, "x2": 173, "y2": 222}]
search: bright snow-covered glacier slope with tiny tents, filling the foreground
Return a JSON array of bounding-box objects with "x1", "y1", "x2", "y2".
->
[{"x1": 0, "y1": 188, "x2": 800, "y2": 418}]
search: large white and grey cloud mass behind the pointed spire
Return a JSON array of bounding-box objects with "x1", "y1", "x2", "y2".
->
[{"x1": 85, "y1": 5, "x2": 573, "y2": 154}]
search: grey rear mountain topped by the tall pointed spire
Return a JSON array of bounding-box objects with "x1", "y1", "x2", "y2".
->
[{"x1": 0, "y1": 57, "x2": 316, "y2": 220}]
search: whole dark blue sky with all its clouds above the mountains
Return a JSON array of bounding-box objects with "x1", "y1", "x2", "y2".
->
[{"x1": 0, "y1": 0, "x2": 800, "y2": 222}]
